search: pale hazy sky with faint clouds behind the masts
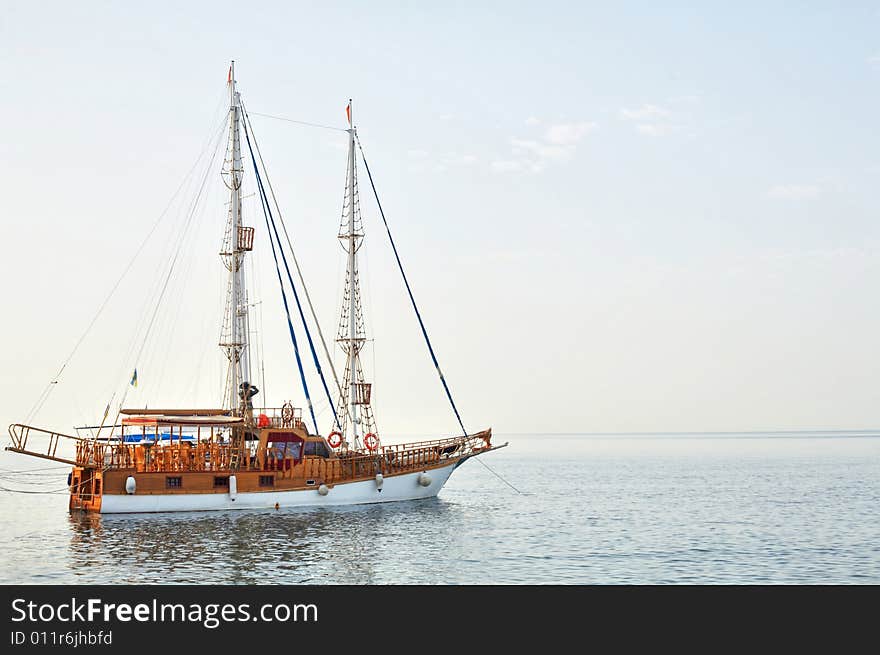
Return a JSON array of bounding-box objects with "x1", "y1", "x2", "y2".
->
[{"x1": 0, "y1": 0, "x2": 880, "y2": 437}]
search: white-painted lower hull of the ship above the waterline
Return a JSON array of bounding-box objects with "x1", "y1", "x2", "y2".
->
[{"x1": 98, "y1": 460, "x2": 461, "y2": 514}]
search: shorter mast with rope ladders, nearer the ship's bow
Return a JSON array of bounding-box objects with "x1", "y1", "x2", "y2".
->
[{"x1": 336, "y1": 100, "x2": 376, "y2": 448}]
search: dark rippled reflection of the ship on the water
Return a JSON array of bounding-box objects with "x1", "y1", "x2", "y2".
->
[{"x1": 68, "y1": 498, "x2": 467, "y2": 585}]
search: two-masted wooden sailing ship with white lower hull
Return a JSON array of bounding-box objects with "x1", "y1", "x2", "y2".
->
[{"x1": 6, "y1": 62, "x2": 507, "y2": 514}]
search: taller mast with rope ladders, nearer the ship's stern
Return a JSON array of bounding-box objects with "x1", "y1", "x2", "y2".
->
[{"x1": 220, "y1": 61, "x2": 254, "y2": 412}]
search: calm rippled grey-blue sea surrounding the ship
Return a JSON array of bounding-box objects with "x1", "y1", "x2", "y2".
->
[{"x1": 0, "y1": 431, "x2": 880, "y2": 584}]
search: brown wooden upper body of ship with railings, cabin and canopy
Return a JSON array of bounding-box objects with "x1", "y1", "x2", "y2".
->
[{"x1": 10, "y1": 407, "x2": 491, "y2": 511}]
